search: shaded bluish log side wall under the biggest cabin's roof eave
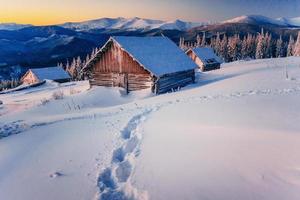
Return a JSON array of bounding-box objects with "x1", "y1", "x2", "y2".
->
[{"x1": 155, "y1": 70, "x2": 195, "y2": 94}]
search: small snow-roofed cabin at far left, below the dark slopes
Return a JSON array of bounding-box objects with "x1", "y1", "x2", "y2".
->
[{"x1": 21, "y1": 67, "x2": 71, "y2": 84}]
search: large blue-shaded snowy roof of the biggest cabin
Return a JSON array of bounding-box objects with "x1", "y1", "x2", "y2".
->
[{"x1": 111, "y1": 36, "x2": 197, "y2": 76}]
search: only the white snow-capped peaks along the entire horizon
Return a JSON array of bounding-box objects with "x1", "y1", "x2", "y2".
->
[{"x1": 0, "y1": 15, "x2": 300, "y2": 31}]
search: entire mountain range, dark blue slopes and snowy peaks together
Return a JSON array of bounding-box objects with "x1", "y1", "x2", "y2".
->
[{"x1": 0, "y1": 15, "x2": 300, "y2": 72}]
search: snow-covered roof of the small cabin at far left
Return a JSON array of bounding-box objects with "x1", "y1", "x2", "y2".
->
[{"x1": 29, "y1": 67, "x2": 70, "y2": 80}]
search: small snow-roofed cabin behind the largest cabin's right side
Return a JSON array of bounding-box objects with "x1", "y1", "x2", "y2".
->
[{"x1": 186, "y1": 47, "x2": 222, "y2": 72}]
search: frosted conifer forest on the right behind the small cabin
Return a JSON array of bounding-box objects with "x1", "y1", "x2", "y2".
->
[{"x1": 179, "y1": 29, "x2": 300, "y2": 62}]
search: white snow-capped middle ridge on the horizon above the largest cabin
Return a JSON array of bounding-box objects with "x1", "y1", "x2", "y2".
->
[{"x1": 59, "y1": 17, "x2": 202, "y2": 31}]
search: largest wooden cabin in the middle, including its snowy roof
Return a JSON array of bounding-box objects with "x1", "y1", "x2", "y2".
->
[{"x1": 82, "y1": 36, "x2": 197, "y2": 94}]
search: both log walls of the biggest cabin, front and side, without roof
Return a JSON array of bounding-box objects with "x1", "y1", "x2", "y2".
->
[{"x1": 90, "y1": 42, "x2": 195, "y2": 94}]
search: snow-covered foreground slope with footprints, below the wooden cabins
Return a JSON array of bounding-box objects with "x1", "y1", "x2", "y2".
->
[{"x1": 0, "y1": 57, "x2": 300, "y2": 200}]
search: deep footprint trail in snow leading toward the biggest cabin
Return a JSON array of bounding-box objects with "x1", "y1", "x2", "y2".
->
[{"x1": 98, "y1": 109, "x2": 156, "y2": 200}]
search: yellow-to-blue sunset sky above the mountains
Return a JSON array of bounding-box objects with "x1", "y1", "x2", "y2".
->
[{"x1": 0, "y1": 0, "x2": 300, "y2": 25}]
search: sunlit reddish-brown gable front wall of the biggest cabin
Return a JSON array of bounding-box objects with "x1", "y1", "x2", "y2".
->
[{"x1": 90, "y1": 42, "x2": 153, "y2": 92}]
